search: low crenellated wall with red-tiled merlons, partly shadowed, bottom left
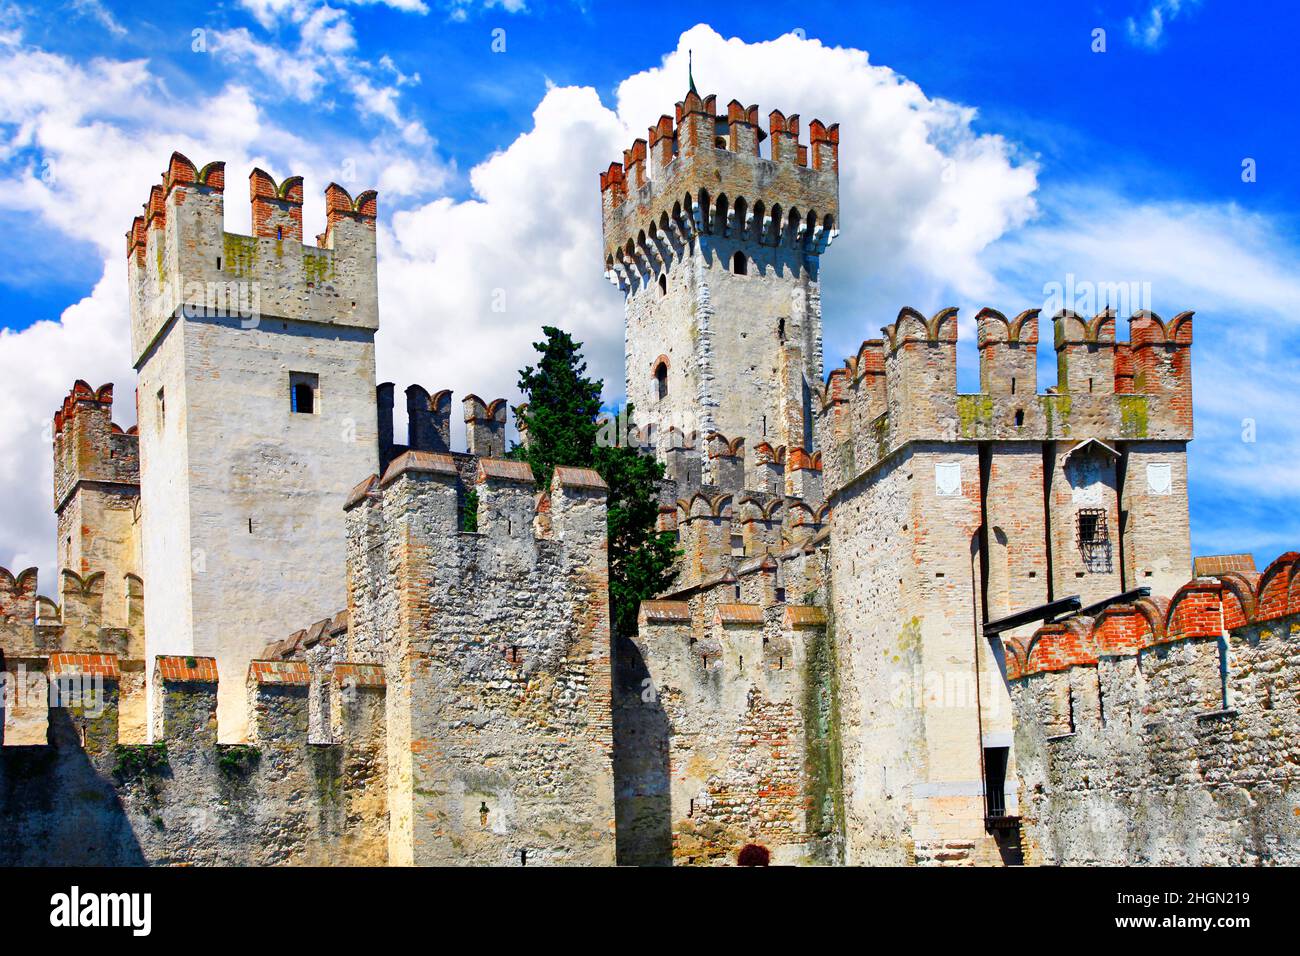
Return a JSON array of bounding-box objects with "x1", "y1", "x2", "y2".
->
[{"x1": 0, "y1": 653, "x2": 387, "y2": 866}]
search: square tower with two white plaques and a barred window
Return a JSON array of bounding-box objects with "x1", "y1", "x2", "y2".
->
[{"x1": 819, "y1": 308, "x2": 1192, "y2": 864}]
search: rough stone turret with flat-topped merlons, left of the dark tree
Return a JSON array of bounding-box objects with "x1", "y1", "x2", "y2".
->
[{"x1": 348, "y1": 451, "x2": 615, "y2": 866}]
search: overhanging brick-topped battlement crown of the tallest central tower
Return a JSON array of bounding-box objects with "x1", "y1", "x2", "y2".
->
[{"x1": 601, "y1": 90, "x2": 840, "y2": 286}]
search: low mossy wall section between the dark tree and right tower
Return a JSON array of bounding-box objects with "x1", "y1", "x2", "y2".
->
[{"x1": 615, "y1": 590, "x2": 841, "y2": 866}]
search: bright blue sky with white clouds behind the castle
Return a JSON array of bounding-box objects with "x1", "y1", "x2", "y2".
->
[{"x1": 0, "y1": 0, "x2": 1300, "y2": 587}]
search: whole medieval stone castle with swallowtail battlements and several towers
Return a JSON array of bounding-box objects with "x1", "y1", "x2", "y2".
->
[{"x1": 0, "y1": 85, "x2": 1300, "y2": 866}]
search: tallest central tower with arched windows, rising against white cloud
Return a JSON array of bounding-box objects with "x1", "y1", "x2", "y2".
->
[{"x1": 601, "y1": 83, "x2": 840, "y2": 463}]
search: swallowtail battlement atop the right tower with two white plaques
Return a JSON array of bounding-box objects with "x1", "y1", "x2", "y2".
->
[{"x1": 818, "y1": 308, "x2": 1192, "y2": 488}]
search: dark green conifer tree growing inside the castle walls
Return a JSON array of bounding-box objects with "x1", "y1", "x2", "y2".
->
[{"x1": 511, "y1": 325, "x2": 679, "y2": 635}]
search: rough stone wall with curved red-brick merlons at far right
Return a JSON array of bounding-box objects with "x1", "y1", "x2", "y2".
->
[{"x1": 1006, "y1": 553, "x2": 1300, "y2": 865}]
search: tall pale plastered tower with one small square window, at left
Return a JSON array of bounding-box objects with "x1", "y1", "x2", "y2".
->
[{"x1": 127, "y1": 153, "x2": 378, "y2": 739}]
